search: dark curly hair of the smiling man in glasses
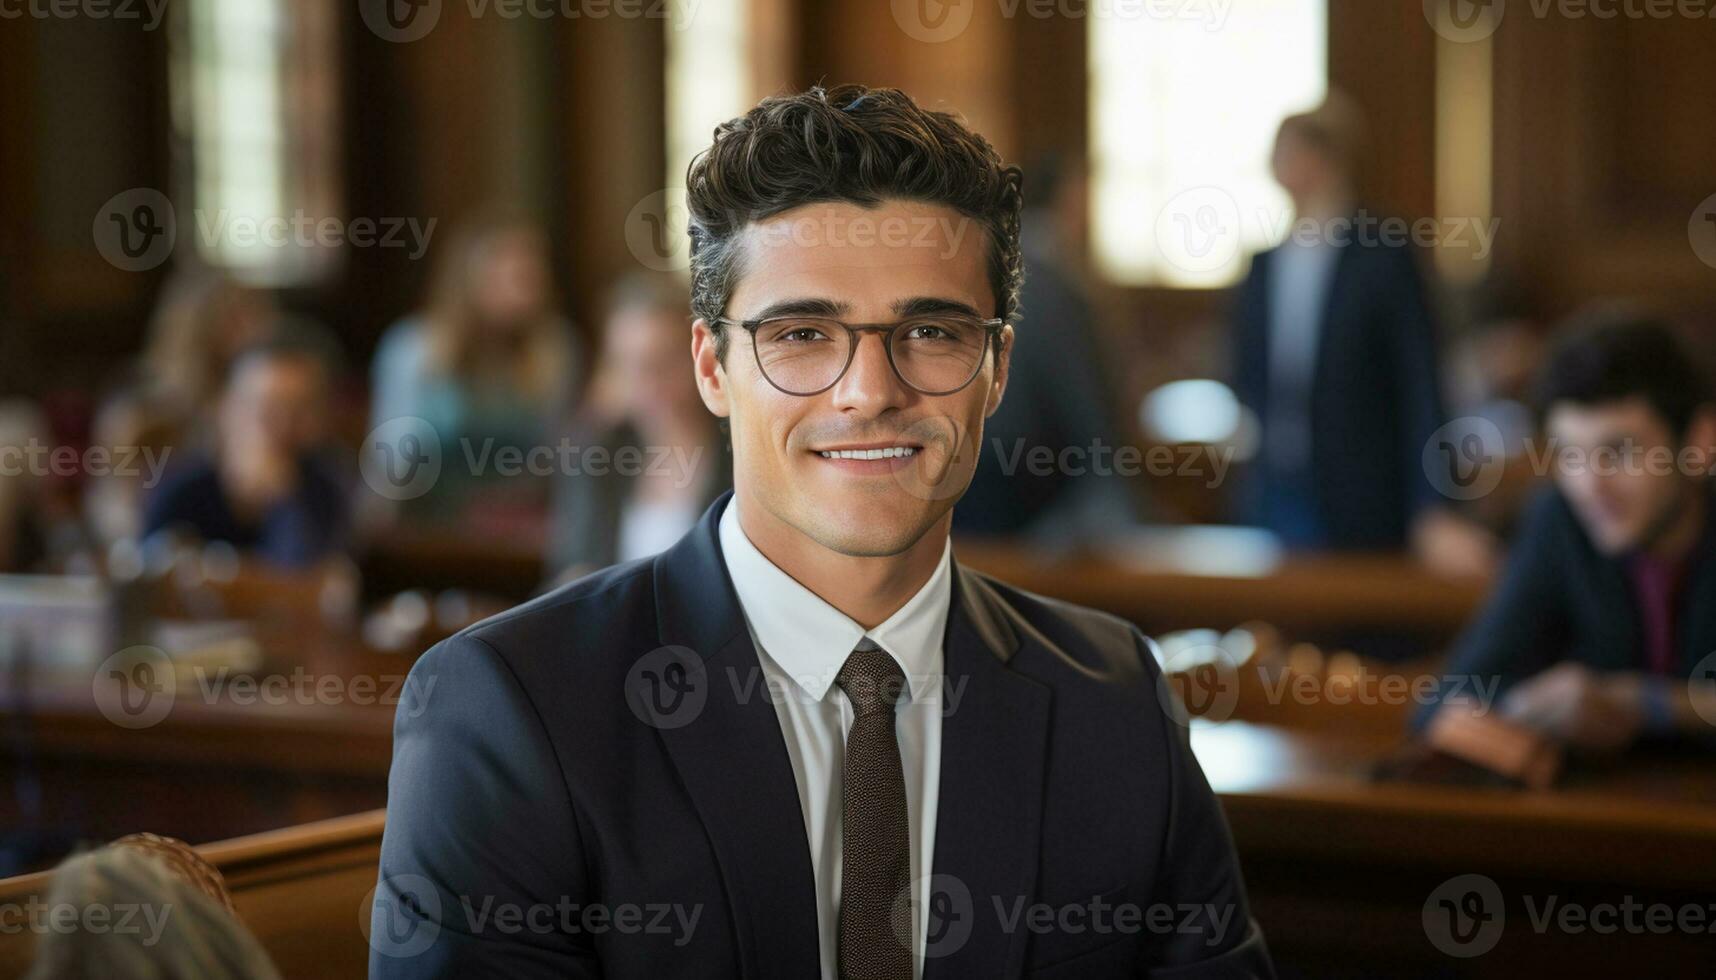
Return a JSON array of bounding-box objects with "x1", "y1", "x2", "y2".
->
[{"x1": 685, "y1": 86, "x2": 1024, "y2": 357}]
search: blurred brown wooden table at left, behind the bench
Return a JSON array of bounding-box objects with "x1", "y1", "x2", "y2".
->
[{"x1": 0, "y1": 633, "x2": 403, "y2": 870}]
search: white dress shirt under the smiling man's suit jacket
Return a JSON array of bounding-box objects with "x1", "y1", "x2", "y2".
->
[{"x1": 721, "y1": 498, "x2": 952, "y2": 980}]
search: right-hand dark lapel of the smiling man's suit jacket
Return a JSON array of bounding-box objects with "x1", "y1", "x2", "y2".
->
[{"x1": 923, "y1": 563, "x2": 1050, "y2": 980}]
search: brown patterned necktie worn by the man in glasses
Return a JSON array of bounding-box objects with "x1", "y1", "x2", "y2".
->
[{"x1": 834, "y1": 637, "x2": 911, "y2": 980}]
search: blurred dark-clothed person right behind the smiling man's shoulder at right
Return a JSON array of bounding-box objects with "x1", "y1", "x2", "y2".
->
[{"x1": 954, "y1": 149, "x2": 1138, "y2": 537}]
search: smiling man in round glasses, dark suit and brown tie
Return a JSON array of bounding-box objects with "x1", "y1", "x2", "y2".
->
[{"x1": 371, "y1": 86, "x2": 1273, "y2": 980}]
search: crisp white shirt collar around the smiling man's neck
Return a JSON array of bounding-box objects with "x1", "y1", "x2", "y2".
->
[{"x1": 719, "y1": 496, "x2": 952, "y2": 702}]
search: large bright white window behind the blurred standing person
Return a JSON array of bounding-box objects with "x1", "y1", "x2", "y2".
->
[{"x1": 1088, "y1": 0, "x2": 1328, "y2": 288}]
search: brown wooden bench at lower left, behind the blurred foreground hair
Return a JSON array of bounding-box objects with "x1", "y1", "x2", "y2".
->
[{"x1": 0, "y1": 810, "x2": 386, "y2": 980}]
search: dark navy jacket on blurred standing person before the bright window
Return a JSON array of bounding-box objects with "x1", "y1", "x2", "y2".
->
[{"x1": 1232, "y1": 233, "x2": 1445, "y2": 551}]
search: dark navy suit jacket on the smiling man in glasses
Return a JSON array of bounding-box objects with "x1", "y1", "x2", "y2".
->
[{"x1": 371, "y1": 494, "x2": 1273, "y2": 980}]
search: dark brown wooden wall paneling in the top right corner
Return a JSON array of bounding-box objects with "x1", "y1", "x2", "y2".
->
[{"x1": 1496, "y1": 17, "x2": 1716, "y2": 323}]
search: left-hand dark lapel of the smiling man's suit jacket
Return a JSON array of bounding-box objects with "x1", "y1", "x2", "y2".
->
[{"x1": 656, "y1": 494, "x2": 820, "y2": 980}]
